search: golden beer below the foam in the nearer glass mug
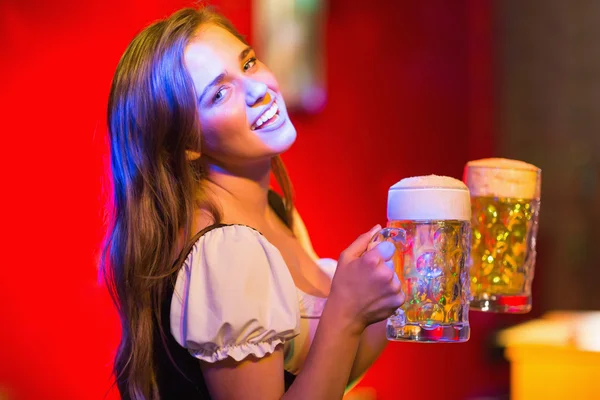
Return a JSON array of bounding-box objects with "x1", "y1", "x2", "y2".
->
[{"x1": 388, "y1": 220, "x2": 471, "y2": 342}]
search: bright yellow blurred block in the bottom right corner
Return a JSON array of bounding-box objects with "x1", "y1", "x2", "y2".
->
[{"x1": 498, "y1": 312, "x2": 600, "y2": 400}]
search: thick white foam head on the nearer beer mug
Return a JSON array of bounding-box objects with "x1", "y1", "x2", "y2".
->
[{"x1": 387, "y1": 175, "x2": 471, "y2": 221}]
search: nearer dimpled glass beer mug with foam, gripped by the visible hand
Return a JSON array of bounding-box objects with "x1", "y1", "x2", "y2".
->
[{"x1": 371, "y1": 175, "x2": 471, "y2": 343}]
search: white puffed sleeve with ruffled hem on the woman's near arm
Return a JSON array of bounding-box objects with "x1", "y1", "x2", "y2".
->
[{"x1": 170, "y1": 225, "x2": 300, "y2": 362}]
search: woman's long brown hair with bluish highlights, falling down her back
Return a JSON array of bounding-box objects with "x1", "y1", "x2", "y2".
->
[{"x1": 102, "y1": 7, "x2": 293, "y2": 400}]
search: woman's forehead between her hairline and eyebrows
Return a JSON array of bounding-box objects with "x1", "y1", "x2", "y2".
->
[{"x1": 184, "y1": 24, "x2": 246, "y2": 90}]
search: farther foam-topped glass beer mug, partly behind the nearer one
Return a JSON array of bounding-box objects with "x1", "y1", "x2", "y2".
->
[{"x1": 463, "y1": 158, "x2": 541, "y2": 313}]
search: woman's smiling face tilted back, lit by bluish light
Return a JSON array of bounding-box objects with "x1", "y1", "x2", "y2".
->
[{"x1": 185, "y1": 24, "x2": 296, "y2": 167}]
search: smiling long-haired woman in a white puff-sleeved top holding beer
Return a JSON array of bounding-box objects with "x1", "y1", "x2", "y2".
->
[{"x1": 104, "y1": 8, "x2": 404, "y2": 399}]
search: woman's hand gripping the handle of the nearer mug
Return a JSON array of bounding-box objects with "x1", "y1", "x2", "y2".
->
[{"x1": 327, "y1": 225, "x2": 405, "y2": 334}]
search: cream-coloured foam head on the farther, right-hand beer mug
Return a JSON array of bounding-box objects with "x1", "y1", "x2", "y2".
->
[{"x1": 463, "y1": 158, "x2": 541, "y2": 199}]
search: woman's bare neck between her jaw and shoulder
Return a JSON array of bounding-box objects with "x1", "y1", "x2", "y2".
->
[{"x1": 205, "y1": 159, "x2": 271, "y2": 222}]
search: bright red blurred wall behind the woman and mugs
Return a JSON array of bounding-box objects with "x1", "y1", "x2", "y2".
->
[{"x1": 0, "y1": 0, "x2": 508, "y2": 400}]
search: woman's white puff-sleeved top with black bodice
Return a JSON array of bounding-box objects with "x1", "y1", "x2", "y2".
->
[{"x1": 155, "y1": 193, "x2": 337, "y2": 399}]
